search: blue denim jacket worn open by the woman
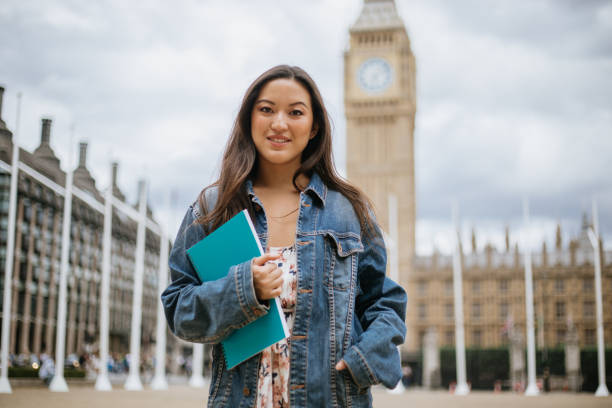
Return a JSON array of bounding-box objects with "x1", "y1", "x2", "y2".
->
[{"x1": 162, "y1": 173, "x2": 406, "y2": 408}]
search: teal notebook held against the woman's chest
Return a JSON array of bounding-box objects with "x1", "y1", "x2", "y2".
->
[{"x1": 187, "y1": 210, "x2": 289, "y2": 369}]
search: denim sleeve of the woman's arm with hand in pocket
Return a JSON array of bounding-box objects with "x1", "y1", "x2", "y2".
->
[{"x1": 343, "y1": 223, "x2": 407, "y2": 388}]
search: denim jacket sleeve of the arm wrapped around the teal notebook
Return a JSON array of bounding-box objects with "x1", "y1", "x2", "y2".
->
[{"x1": 161, "y1": 206, "x2": 268, "y2": 343}]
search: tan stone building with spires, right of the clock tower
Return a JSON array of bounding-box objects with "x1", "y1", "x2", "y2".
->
[{"x1": 407, "y1": 222, "x2": 612, "y2": 351}]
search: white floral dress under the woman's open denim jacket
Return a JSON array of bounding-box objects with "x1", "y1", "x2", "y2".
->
[{"x1": 255, "y1": 245, "x2": 297, "y2": 408}]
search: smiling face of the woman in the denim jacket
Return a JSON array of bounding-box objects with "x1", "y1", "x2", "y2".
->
[{"x1": 251, "y1": 78, "x2": 315, "y2": 169}]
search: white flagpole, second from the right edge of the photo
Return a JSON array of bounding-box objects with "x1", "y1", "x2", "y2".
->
[{"x1": 523, "y1": 197, "x2": 540, "y2": 396}]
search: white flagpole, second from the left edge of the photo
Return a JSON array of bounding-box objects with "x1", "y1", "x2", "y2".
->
[{"x1": 49, "y1": 126, "x2": 74, "y2": 392}]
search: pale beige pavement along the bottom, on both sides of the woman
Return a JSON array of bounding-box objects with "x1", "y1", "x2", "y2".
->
[{"x1": 0, "y1": 382, "x2": 612, "y2": 408}]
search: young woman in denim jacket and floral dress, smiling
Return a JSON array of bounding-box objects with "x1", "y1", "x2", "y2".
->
[{"x1": 162, "y1": 65, "x2": 406, "y2": 408}]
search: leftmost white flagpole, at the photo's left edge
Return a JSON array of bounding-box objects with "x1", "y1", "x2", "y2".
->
[{"x1": 0, "y1": 92, "x2": 21, "y2": 394}]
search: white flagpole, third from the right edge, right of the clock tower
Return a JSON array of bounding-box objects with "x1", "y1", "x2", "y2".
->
[{"x1": 452, "y1": 201, "x2": 470, "y2": 395}]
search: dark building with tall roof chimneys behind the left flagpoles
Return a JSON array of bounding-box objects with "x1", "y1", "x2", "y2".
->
[{"x1": 0, "y1": 88, "x2": 159, "y2": 355}]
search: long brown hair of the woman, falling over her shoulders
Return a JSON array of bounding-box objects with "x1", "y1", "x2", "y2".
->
[{"x1": 197, "y1": 65, "x2": 374, "y2": 236}]
